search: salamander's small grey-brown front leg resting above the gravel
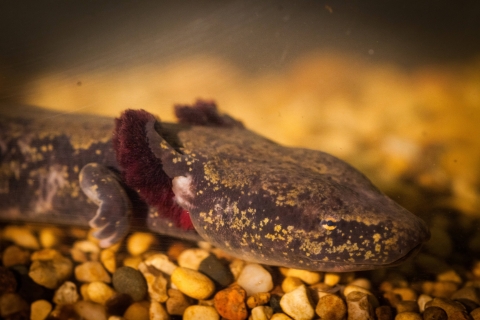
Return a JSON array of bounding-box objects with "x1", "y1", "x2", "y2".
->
[{"x1": 79, "y1": 163, "x2": 132, "y2": 248}]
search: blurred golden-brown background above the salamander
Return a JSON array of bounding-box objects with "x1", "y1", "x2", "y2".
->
[{"x1": 0, "y1": 0, "x2": 480, "y2": 222}]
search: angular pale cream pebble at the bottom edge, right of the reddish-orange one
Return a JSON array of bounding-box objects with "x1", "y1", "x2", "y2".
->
[{"x1": 280, "y1": 285, "x2": 315, "y2": 320}]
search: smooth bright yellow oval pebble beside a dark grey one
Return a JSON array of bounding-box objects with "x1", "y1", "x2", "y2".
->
[{"x1": 171, "y1": 267, "x2": 215, "y2": 300}]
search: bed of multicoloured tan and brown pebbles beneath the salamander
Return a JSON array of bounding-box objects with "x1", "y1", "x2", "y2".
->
[{"x1": 0, "y1": 214, "x2": 480, "y2": 320}]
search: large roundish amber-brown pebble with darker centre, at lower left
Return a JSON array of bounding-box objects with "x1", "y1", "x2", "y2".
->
[{"x1": 28, "y1": 249, "x2": 73, "y2": 289}]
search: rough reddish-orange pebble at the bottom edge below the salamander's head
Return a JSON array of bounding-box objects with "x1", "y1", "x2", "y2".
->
[{"x1": 213, "y1": 284, "x2": 248, "y2": 320}]
